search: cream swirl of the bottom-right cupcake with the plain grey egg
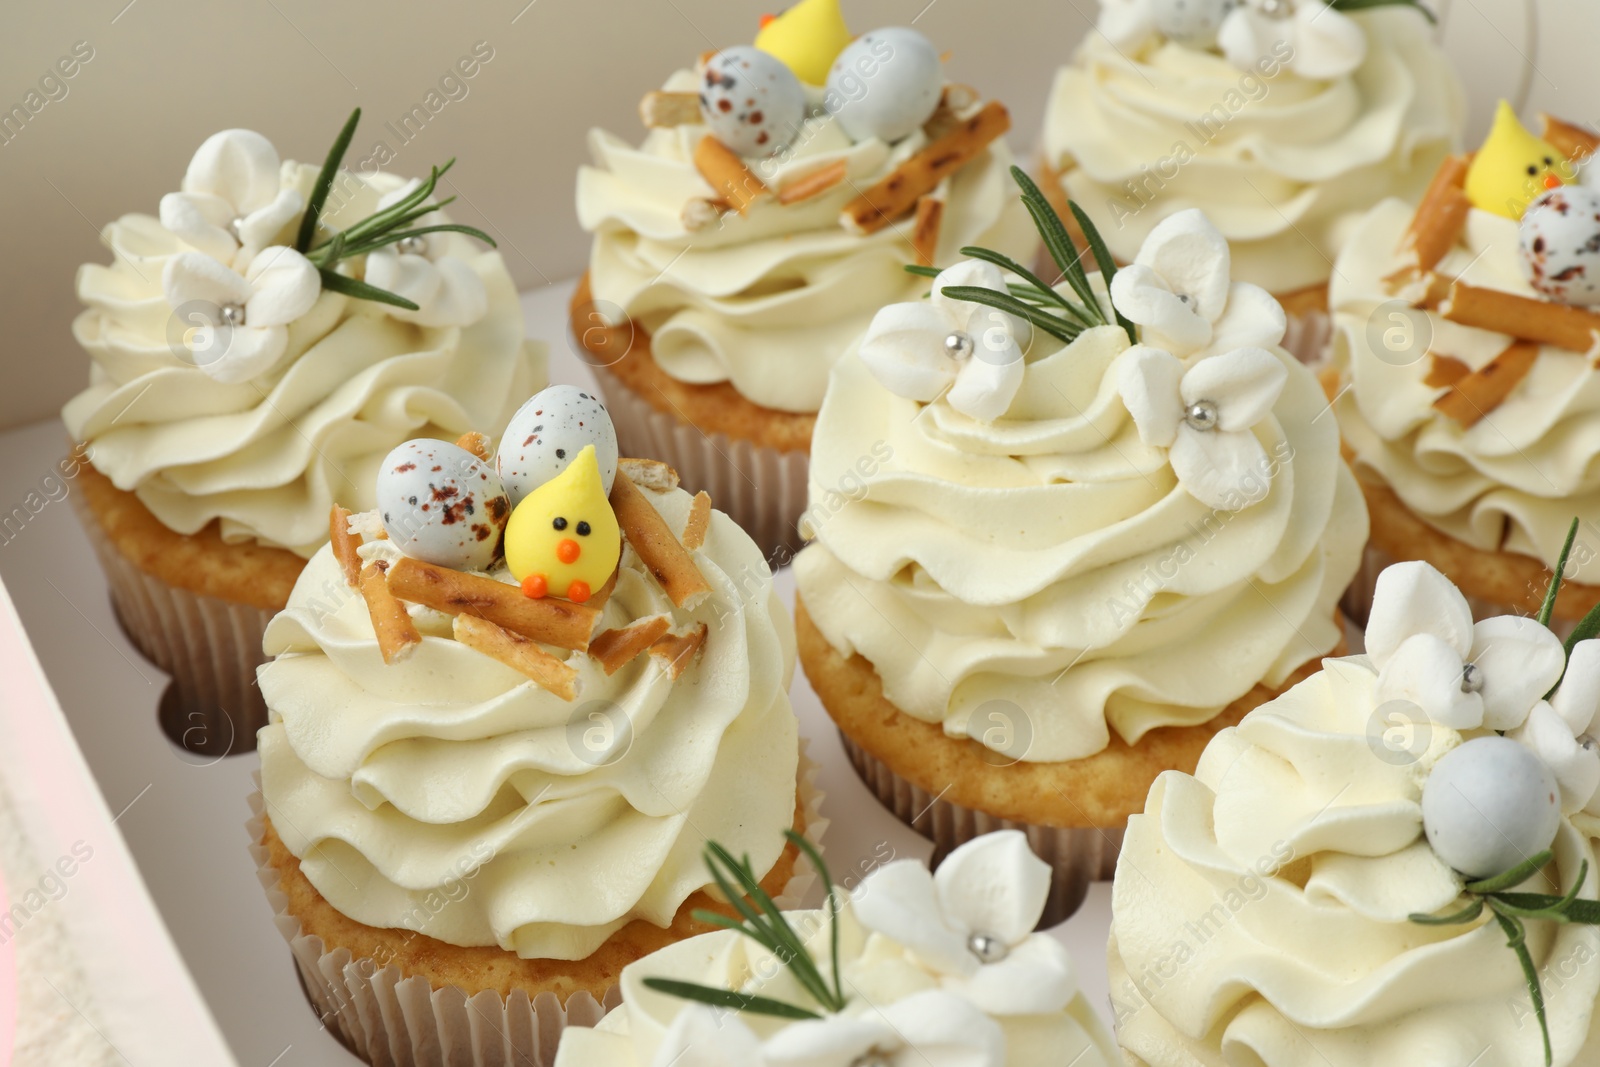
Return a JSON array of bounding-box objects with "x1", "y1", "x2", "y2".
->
[{"x1": 1110, "y1": 656, "x2": 1600, "y2": 1067}]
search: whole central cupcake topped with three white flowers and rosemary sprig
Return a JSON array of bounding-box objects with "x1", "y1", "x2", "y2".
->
[{"x1": 795, "y1": 171, "x2": 1366, "y2": 921}]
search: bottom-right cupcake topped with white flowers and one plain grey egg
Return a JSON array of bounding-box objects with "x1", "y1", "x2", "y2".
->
[{"x1": 1110, "y1": 561, "x2": 1600, "y2": 1067}]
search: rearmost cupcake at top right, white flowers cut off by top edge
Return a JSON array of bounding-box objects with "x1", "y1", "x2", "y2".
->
[{"x1": 1043, "y1": 0, "x2": 1464, "y2": 360}]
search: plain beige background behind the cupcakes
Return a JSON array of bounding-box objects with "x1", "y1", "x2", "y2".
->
[{"x1": 0, "y1": 0, "x2": 1574, "y2": 427}]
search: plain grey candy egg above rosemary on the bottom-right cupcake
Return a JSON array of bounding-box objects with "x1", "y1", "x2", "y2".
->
[{"x1": 1422, "y1": 737, "x2": 1562, "y2": 878}]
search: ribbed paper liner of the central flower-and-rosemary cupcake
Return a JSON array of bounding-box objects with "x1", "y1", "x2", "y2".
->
[{"x1": 838, "y1": 731, "x2": 1123, "y2": 929}]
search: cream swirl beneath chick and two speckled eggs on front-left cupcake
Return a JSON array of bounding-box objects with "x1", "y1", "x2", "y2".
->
[{"x1": 258, "y1": 491, "x2": 798, "y2": 960}]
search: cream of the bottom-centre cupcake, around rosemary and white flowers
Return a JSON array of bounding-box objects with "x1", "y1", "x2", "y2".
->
[{"x1": 555, "y1": 910, "x2": 1117, "y2": 1067}]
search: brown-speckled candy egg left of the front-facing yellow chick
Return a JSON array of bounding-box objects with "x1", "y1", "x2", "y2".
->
[{"x1": 378, "y1": 440, "x2": 510, "y2": 571}]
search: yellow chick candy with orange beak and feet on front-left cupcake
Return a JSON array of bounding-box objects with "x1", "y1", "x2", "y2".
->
[{"x1": 506, "y1": 445, "x2": 622, "y2": 603}]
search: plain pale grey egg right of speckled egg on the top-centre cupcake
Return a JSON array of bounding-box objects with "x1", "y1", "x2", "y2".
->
[{"x1": 822, "y1": 26, "x2": 944, "y2": 141}]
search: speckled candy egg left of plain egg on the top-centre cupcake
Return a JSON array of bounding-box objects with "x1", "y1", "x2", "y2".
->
[{"x1": 701, "y1": 45, "x2": 806, "y2": 158}]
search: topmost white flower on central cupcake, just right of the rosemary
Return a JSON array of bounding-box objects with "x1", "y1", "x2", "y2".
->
[{"x1": 1110, "y1": 208, "x2": 1288, "y2": 357}]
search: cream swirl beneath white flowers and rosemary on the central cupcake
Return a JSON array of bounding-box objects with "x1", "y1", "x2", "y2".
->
[{"x1": 795, "y1": 315, "x2": 1366, "y2": 761}]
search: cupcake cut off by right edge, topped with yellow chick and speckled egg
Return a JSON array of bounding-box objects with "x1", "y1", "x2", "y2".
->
[{"x1": 1333, "y1": 106, "x2": 1600, "y2": 632}]
